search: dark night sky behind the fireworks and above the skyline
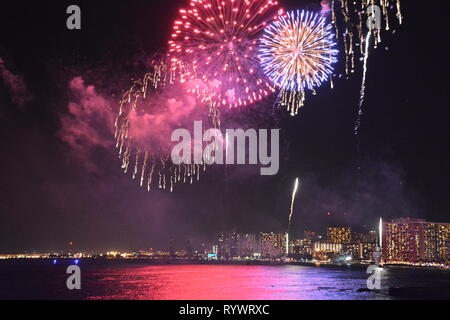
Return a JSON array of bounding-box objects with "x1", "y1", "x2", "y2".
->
[{"x1": 0, "y1": 0, "x2": 450, "y2": 252}]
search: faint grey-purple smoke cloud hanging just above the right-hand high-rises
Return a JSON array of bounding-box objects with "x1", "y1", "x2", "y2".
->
[{"x1": 294, "y1": 162, "x2": 423, "y2": 234}]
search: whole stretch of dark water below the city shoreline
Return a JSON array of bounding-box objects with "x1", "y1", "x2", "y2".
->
[{"x1": 0, "y1": 261, "x2": 450, "y2": 300}]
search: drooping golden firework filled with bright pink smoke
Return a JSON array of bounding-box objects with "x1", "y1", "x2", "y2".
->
[{"x1": 115, "y1": 62, "x2": 217, "y2": 192}]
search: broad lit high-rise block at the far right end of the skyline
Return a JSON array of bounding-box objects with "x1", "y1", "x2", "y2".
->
[{"x1": 383, "y1": 218, "x2": 450, "y2": 263}]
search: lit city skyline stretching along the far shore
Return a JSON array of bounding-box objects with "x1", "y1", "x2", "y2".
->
[{"x1": 4, "y1": 218, "x2": 450, "y2": 267}]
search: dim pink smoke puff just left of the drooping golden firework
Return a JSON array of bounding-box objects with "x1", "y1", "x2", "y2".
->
[{"x1": 59, "y1": 77, "x2": 114, "y2": 171}]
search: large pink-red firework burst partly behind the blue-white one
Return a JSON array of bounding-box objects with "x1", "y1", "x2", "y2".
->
[{"x1": 169, "y1": 0, "x2": 283, "y2": 107}]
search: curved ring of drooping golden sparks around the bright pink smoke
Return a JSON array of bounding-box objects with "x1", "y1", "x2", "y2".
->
[{"x1": 115, "y1": 62, "x2": 219, "y2": 192}]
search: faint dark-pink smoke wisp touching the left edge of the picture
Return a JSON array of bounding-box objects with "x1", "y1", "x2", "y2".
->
[{"x1": 0, "y1": 58, "x2": 32, "y2": 107}]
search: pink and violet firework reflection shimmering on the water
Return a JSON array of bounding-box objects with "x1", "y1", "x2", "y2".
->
[{"x1": 86, "y1": 265, "x2": 387, "y2": 300}]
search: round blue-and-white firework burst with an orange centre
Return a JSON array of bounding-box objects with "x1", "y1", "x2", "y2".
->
[{"x1": 259, "y1": 11, "x2": 337, "y2": 115}]
